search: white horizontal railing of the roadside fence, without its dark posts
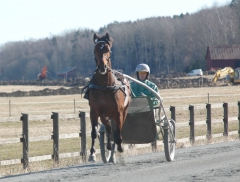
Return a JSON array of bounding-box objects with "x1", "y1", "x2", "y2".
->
[{"x1": 0, "y1": 103, "x2": 238, "y2": 166}]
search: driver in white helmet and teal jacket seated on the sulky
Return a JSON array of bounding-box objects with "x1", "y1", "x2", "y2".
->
[{"x1": 131, "y1": 63, "x2": 159, "y2": 106}]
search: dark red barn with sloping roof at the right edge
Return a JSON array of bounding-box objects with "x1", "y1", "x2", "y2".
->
[{"x1": 206, "y1": 45, "x2": 240, "y2": 70}]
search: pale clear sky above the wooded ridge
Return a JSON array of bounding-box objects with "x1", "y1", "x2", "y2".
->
[{"x1": 0, "y1": 0, "x2": 231, "y2": 46}]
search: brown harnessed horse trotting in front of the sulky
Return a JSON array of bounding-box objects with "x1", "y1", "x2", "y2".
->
[{"x1": 88, "y1": 33, "x2": 131, "y2": 161}]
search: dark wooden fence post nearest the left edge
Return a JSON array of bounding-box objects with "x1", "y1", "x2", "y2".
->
[{"x1": 20, "y1": 113, "x2": 29, "y2": 169}]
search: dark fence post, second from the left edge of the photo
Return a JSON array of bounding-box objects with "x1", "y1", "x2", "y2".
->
[{"x1": 51, "y1": 112, "x2": 59, "y2": 165}]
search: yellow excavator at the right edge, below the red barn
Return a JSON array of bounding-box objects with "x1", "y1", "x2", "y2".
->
[{"x1": 212, "y1": 67, "x2": 240, "y2": 84}]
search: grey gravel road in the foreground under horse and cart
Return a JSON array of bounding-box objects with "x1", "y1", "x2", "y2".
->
[{"x1": 0, "y1": 140, "x2": 240, "y2": 182}]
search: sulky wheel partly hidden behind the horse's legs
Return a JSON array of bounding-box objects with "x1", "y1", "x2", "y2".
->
[{"x1": 99, "y1": 132, "x2": 111, "y2": 163}]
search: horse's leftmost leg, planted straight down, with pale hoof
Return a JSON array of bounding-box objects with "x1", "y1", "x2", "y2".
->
[{"x1": 88, "y1": 112, "x2": 98, "y2": 162}]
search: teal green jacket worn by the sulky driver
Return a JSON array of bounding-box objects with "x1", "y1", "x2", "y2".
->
[{"x1": 131, "y1": 80, "x2": 159, "y2": 106}]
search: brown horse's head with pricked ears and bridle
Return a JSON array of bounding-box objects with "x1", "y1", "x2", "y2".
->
[{"x1": 93, "y1": 33, "x2": 113, "y2": 74}]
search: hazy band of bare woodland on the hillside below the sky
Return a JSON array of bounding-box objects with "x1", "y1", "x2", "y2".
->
[{"x1": 0, "y1": 0, "x2": 240, "y2": 80}]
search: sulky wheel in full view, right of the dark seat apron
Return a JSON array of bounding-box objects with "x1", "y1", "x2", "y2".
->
[{"x1": 163, "y1": 120, "x2": 176, "y2": 162}]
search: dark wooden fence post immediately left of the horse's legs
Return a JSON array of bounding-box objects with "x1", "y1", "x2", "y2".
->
[{"x1": 79, "y1": 111, "x2": 87, "y2": 162}]
